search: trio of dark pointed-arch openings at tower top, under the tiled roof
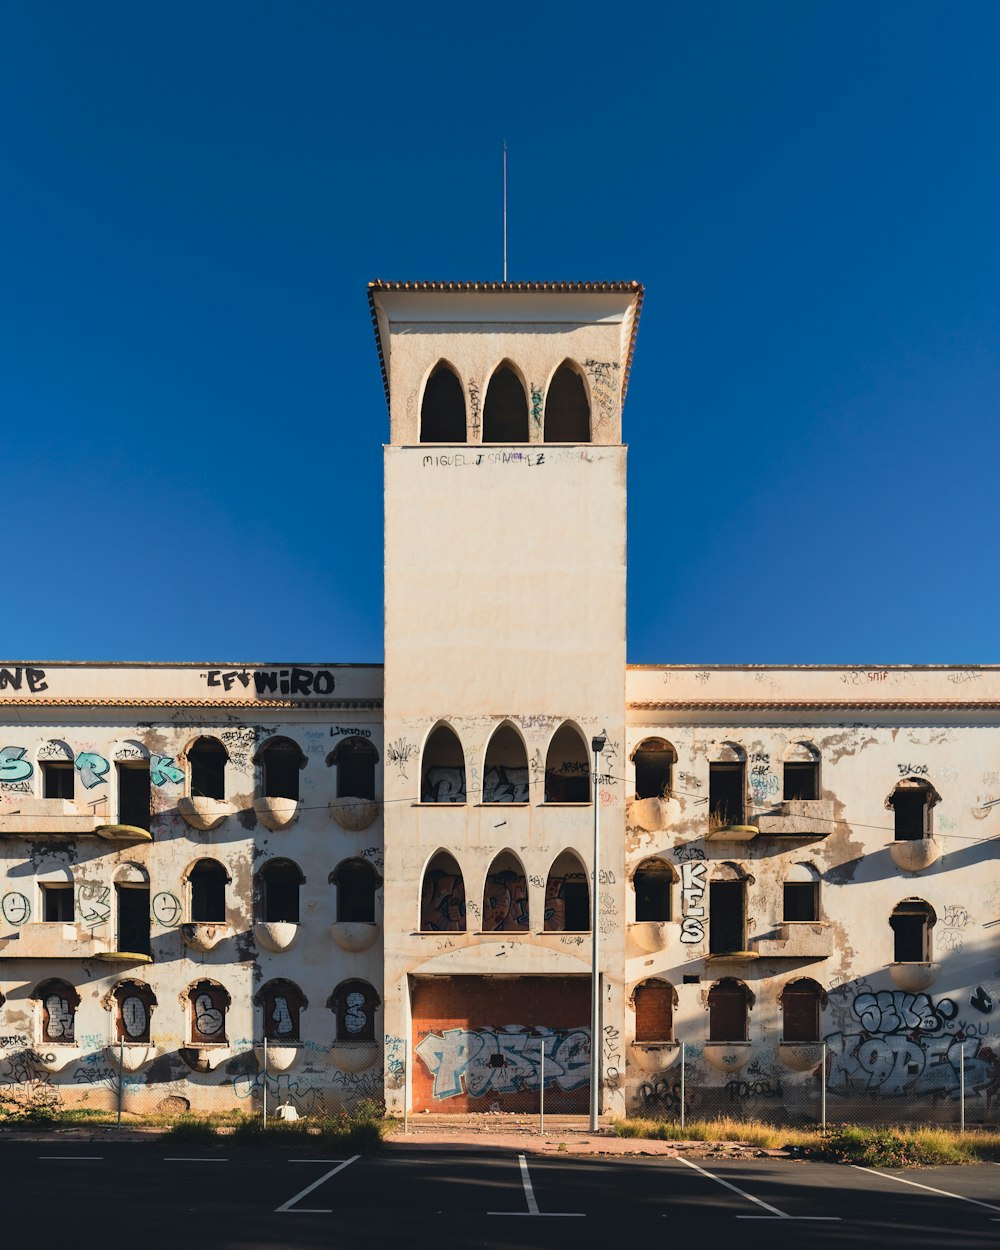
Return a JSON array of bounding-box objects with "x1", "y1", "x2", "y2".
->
[{"x1": 420, "y1": 360, "x2": 591, "y2": 444}]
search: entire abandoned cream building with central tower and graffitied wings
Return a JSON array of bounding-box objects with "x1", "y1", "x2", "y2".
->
[{"x1": 0, "y1": 283, "x2": 1000, "y2": 1119}]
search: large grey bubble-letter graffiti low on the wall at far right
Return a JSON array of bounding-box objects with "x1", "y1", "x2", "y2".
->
[{"x1": 825, "y1": 990, "x2": 1000, "y2": 1101}]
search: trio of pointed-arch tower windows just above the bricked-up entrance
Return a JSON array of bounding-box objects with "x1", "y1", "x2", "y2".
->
[{"x1": 420, "y1": 850, "x2": 590, "y2": 933}]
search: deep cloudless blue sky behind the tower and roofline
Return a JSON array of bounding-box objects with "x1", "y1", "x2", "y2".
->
[{"x1": 0, "y1": 0, "x2": 1000, "y2": 663}]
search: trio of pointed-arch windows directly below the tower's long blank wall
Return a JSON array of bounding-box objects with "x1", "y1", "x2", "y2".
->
[{"x1": 420, "y1": 721, "x2": 591, "y2": 803}]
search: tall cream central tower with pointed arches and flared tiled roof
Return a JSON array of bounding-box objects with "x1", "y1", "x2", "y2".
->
[{"x1": 369, "y1": 281, "x2": 643, "y2": 1113}]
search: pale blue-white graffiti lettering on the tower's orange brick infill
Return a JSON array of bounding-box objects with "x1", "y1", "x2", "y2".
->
[{"x1": 414, "y1": 1025, "x2": 590, "y2": 1101}]
